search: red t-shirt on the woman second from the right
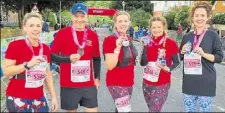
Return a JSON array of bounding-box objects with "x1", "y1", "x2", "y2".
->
[{"x1": 144, "y1": 35, "x2": 179, "y2": 85}]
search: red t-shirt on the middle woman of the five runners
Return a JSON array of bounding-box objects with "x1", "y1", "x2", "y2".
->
[{"x1": 103, "y1": 35, "x2": 134, "y2": 86}]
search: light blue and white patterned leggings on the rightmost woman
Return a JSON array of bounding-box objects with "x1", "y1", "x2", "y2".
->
[{"x1": 184, "y1": 94, "x2": 213, "y2": 112}]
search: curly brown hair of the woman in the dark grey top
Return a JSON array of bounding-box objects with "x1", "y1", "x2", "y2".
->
[{"x1": 189, "y1": 1, "x2": 212, "y2": 22}]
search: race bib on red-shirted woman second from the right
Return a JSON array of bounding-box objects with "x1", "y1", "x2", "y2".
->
[{"x1": 143, "y1": 62, "x2": 161, "y2": 82}]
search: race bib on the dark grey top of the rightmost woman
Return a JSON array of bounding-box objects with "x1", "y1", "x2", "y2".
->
[{"x1": 184, "y1": 52, "x2": 202, "y2": 75}]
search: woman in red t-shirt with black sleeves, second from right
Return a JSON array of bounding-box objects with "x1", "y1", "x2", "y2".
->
[{"x1": 140, "y1": 17, "x2": 179, "y2": 112}]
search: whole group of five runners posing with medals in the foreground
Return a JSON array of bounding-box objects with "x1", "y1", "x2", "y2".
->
[{"x1": 3, "y1": 1, "x2": 223, "y2": 112}]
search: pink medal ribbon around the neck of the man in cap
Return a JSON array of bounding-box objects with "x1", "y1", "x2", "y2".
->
[{"x1": 71, "y1": 26, "x2": 87, "y2": 49}]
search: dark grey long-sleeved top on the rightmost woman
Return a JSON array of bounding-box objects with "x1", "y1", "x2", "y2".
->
[{"x1": 180, "y1": 30, "x2": 223, "y2": 96}]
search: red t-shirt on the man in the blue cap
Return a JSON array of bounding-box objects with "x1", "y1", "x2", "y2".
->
[{"x1": 51, "y1": 26, "x2": 100, "y2": 88}]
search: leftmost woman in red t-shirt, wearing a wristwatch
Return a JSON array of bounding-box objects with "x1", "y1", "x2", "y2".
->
[{"x1": 3, "y1": 13, "x2": 58, "y2": 112}]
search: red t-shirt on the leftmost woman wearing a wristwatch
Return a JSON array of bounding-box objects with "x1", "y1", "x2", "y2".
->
[{"x1": 5, "y1": 40, "x2": 50, "y2": 99}]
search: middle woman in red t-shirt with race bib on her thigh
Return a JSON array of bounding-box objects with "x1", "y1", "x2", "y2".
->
[{"x1": 103, "y1": 11, "x2": 138, "y2": 112}]
